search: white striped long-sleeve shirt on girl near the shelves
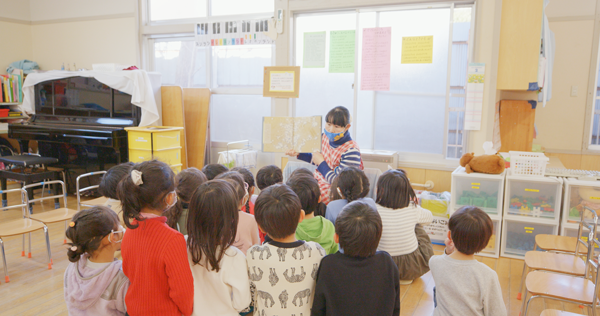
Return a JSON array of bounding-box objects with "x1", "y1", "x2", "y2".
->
[{"x1": 377, "y1": 204, "x2": 433, "y2": 257}]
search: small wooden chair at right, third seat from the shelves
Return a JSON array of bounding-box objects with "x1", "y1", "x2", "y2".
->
[{"x1": 521, "y1": 238, "x2": 600, "y2": 316}]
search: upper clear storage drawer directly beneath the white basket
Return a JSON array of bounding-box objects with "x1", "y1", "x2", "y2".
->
[{"x1": 504, "y1": 170, "x2": 563, "y2": 223}]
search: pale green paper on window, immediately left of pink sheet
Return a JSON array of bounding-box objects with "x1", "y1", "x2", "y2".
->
[{"x1": 329, "y1": 30, "x2": 356, "y2": 73}]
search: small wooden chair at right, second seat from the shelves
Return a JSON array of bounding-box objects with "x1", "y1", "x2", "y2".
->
[{"x1": 517, "y1": 207, "x2": 598, "y2": 300}]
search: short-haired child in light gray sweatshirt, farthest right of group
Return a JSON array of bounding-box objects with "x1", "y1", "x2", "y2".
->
[{"x1": 429, "y1": 206, "x2": 506, "y2": 316}]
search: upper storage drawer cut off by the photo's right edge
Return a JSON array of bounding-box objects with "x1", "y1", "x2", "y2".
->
[{"x1": 563, "y1": 178, "x2": 600, "y2": 225}]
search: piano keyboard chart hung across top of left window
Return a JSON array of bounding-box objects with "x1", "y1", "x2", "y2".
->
[{"x1": 194, "y1": 19, "x2": 275, "y2": 47}]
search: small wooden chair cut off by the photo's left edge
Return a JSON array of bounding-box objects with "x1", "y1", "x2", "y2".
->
[{"x1": 0, "y1": 188, "x2": 52, "y2": 283}]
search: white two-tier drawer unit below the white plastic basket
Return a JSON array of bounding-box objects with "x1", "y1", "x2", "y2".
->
[{"x1": 500, "y1": 170, "x2": 563, "y2": 259}]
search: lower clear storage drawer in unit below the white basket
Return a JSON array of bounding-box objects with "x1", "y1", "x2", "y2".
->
[{"x1": 501, "y1": 218, "x2": 558, "y2": 259}]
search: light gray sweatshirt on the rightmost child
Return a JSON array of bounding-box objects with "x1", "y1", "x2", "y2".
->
[{"x1": 429, "y1": 254, "x2": 507, "y2": 316}]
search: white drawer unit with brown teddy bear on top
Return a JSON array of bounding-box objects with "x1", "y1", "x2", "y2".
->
[{"x1": 449, "y1": 167, "x2": 506, "y2": 258}]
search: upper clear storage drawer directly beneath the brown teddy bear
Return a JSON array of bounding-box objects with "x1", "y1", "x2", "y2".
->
[{"x1": 450, "y1": 167, "x2": 506, "y2": 215}]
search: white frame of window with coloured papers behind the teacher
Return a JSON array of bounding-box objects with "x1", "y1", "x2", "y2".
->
[{"x1": 289, "y1": 1, "x2": 477, "y2": 165}]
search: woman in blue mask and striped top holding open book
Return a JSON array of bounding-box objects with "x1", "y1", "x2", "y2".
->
[{"x1": 286, "y1": 106, "x2": 364, "y2": 204}]
